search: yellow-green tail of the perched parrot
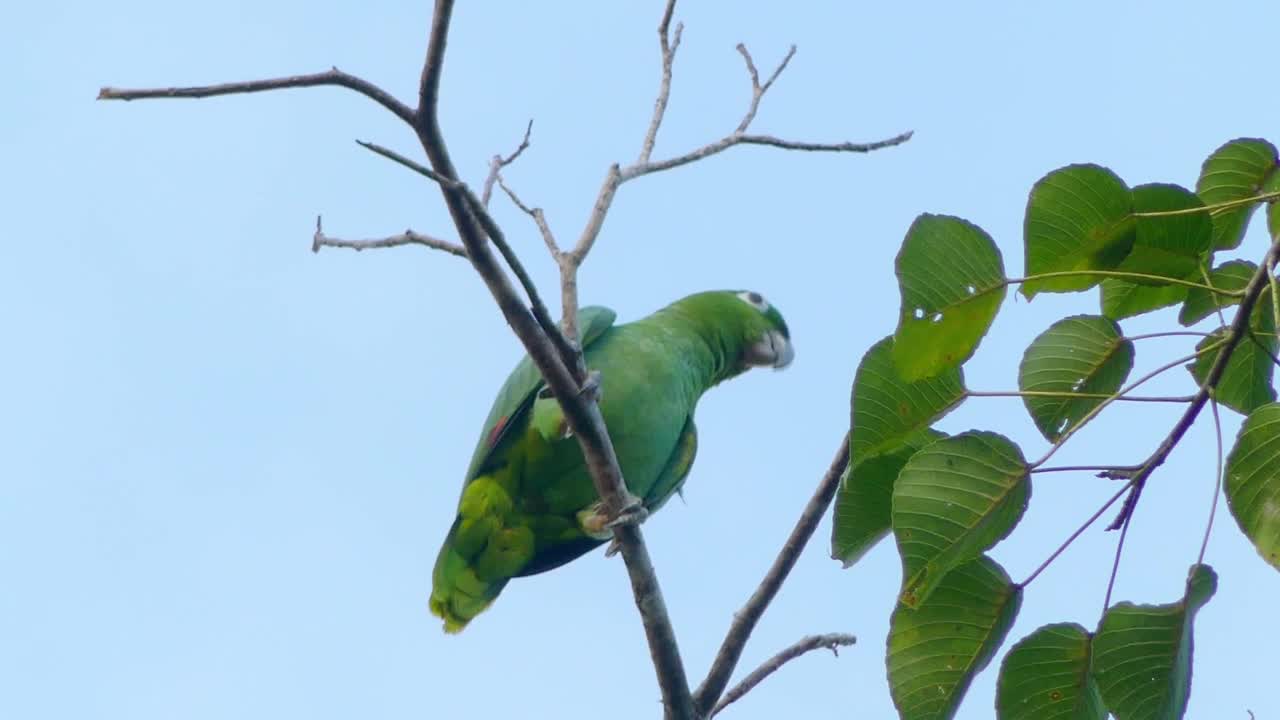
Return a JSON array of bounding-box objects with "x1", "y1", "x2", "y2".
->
[{"x1": 430, "y1": 475, "x2": 534, "y2": 633}]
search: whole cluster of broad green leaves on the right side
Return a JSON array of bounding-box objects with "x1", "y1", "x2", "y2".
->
[{"x1": 832, "y1": 138, "x2": 1280, "y2": 720}]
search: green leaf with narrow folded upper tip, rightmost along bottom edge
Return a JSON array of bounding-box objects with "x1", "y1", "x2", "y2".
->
[{"x1": 1093, "y1": 565, "x2": 1217, "y2": 720}]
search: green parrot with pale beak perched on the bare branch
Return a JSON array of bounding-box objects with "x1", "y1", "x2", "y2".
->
[{"x1": 430, "y1": 291, "x2": 794, "y2": 633}]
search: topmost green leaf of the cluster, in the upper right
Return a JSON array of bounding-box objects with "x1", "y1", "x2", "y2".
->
[{"x1": 1196, "y1": 137, "x2": 1276, "y2": 250}]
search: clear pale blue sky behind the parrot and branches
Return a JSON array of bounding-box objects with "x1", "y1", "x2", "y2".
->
[{"x1": 0, "y1": 0, "x2": 1280, "y2": 720}]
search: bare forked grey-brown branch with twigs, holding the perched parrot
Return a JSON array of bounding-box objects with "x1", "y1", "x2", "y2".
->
[{"x1": 99, "y1": 0, "x2": 910, "y2": 720}]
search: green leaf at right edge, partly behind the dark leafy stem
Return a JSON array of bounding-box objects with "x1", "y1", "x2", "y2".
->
[{"x1": 1187, "y1": 290, "x2": 1276, "y2": 415}]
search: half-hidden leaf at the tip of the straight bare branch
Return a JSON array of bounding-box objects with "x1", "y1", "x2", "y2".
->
[{"x1": 831, "y1": 428, "x2": 946, "y2": 568}]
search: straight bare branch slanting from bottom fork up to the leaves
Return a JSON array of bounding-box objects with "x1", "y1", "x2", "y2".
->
[{"x1": 694, "y1": 434, "x2": 849, "y2": 716}]
